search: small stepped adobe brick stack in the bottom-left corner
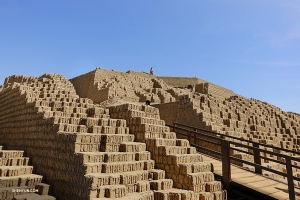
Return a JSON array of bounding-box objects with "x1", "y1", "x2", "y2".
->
[{"x1": 0, "y1": 146, "x2": 55, "y2": 200}]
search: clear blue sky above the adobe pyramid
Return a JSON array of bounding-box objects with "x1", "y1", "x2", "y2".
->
[{"x1": 0, "y1": 0, "x2": 300, "y2": 113}]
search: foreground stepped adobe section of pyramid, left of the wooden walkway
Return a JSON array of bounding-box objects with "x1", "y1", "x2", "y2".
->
[{"x1": 0, "y1": 71, "x2": 226, "y2": 200}]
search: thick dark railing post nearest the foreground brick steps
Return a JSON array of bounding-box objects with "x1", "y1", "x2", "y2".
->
[{"x1": 221, "y1": 140, "x2": 231, "y2": 197}]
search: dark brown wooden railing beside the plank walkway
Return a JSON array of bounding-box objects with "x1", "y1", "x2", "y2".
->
[{"x1": 167, "y1": 123, "x2": 300, "y2": 200}]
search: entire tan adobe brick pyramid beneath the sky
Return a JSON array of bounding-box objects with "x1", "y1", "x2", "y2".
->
[{"x1": 0, "y1": 68, "x2": 300, "y2": 200}]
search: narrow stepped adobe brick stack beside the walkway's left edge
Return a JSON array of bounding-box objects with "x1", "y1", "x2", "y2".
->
[{"x1": 109, "y1": 104, "x2": 226, "y2": 200}]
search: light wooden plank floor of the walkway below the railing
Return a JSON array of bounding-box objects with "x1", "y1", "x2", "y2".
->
[{"x1": 202, "y1": 154, "x2": 300, "y2": 200}]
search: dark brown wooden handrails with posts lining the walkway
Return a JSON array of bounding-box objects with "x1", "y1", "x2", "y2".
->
[{"x1": 167, "y1": 123, "x2": 300, "y2": 200}]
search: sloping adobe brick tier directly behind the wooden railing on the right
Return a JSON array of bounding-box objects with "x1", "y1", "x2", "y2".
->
[{"x1": 155, "y1": 93, "x2": 300, "y2": 184}]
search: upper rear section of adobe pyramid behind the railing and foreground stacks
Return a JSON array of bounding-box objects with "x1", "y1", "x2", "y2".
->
[{"x1": 70, "y1": 68, "x2": 300, "y2": 186}]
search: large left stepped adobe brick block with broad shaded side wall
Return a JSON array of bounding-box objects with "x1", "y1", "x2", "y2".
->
[{"x1": 0, "y1": 74, "x2": 211, "y2": 200}]
